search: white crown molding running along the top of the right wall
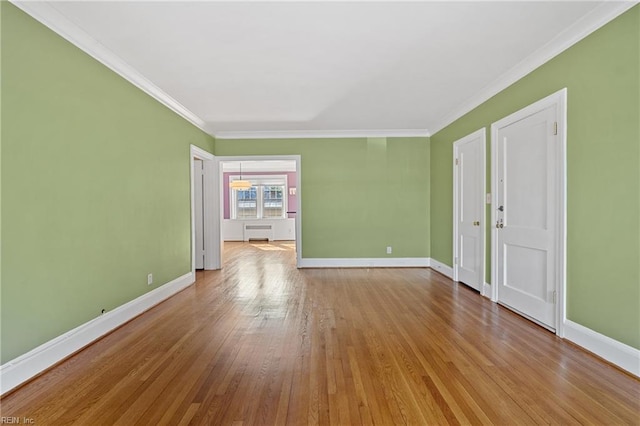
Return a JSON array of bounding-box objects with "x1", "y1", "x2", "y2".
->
[{"x1": 430, "y1": 0, "x2": 638, "y2": 135}]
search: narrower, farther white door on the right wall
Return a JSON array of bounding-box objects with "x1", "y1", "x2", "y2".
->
[{"x1": 453, "y1": 129, "x2": 486, "y2": 291}]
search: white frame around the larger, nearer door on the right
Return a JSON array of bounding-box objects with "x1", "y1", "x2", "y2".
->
[{"x1": 491, "y1": 88, "x2": 567, "y2": 337}]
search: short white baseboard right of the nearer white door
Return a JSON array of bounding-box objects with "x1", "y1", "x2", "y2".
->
[{"x1": 564, "y1": 320, "x2": 640, "y2": 377}]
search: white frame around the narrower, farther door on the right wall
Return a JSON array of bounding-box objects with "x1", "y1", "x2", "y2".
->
[{"x1": 453, "y1": 127, "x2": 489, "y2": 297}]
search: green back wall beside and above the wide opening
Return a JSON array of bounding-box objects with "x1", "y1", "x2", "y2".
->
[{"x1": 215, "y1": 138, "x2": 429, "y2": 258}]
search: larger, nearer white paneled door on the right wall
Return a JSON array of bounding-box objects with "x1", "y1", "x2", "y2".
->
[{"x1": 492, "y1": 93, "x2": 564, "y2": 329}]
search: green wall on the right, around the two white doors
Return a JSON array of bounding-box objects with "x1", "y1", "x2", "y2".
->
[{"x1": 431, "y1": 6, "x2": 640, "y2": 348}]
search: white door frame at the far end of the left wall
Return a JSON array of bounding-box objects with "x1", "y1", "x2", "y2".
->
[{"x1": 189, "y1": 145, "x2": 220, "y2": 278}]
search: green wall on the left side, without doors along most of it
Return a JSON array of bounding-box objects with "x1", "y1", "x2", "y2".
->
[{"x1": 0, "y1": 2, "x2": 213, "y2": 363}]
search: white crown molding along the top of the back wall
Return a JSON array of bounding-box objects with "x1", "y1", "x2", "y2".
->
[{"x1": 214, "y1": 129, "x2": 431, "y2": 139}]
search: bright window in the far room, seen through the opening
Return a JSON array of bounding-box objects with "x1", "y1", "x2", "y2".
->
[{"x1": 229, "y1": 176, "x2": 287, "y2": 219}]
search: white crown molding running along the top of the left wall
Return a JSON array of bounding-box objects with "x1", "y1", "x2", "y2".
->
[{"x1": 9, "y1": 0, "x2": 208, "y2": 133}]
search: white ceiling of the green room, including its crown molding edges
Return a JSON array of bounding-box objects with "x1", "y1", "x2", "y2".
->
[{"x1": 16, "y1": 1, "x2": 634, "y2": 137}]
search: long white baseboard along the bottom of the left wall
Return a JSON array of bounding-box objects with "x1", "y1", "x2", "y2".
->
[{"x1": 0, "y1": 272, "x2": 195, "y2": 395}]
